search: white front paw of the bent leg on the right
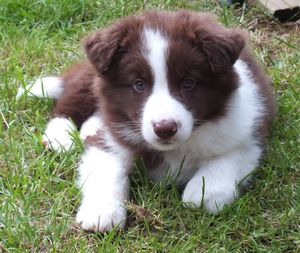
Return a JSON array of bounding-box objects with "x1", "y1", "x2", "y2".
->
[{"x1": 182, "y1": 180, "x2": 236, "y2": 214}]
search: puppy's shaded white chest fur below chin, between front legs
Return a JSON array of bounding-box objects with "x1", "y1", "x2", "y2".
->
[{"x1": 146, "y1": 125, "x2": 237, "y2": 184}]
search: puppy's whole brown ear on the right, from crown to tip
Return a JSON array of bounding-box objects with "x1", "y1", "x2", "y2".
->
[{"x1": 179, "y1": 11, "x2": 246, "y2": 74}]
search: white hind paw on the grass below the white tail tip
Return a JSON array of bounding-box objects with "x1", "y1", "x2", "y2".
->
[{"x1": 43, "y1": 118, "x2": 76, "y2": 152}]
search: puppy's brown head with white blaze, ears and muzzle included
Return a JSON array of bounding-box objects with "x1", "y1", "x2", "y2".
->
[{"x1": 85, "y1": 11, "x2": 245, "y2": 150}]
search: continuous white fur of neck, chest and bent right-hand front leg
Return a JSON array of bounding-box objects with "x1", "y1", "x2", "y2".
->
[{"x1": 154, "y1": 60, "x2": 264, "y2": 213}]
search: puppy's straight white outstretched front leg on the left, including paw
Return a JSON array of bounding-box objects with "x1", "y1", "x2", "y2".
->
[{"x1": 76, "y1": 143, "x2": 131, "y2": 232}]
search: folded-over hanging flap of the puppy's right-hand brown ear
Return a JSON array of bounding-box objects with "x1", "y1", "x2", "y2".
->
[{"x1": 196, "y1": 24, "x2": 245, "y2": 74}]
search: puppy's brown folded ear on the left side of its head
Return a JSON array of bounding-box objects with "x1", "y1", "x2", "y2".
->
[{"x1": 83, "y1": 18, "x2": 137, "y2": 74}]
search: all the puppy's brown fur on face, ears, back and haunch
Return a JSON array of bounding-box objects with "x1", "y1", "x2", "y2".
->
[{"x1": 55, "y1": 11, "x2": 273, "y2": 152}]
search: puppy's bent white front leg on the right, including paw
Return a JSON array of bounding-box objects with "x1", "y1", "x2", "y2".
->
[{"x1": 182, "y1": 145, "x2": 261, "y2": 213}]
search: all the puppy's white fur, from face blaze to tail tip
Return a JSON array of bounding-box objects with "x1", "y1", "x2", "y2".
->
[{"x1": 22, "y1": 20, "x2": 264, "y2": 232}]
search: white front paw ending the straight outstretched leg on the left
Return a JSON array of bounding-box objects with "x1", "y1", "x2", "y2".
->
[{"x1": 76, "y1": 201, "x2": 126, "y2": 232}]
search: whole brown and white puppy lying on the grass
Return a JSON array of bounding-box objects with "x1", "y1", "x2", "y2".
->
[{"x1": 19, "y1": 11, "x2": 274, "y2": 231}]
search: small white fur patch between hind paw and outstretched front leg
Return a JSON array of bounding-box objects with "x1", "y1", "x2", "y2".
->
[{"x1": 80, "y1": 112, "x2": 103, "y2": 141}]
